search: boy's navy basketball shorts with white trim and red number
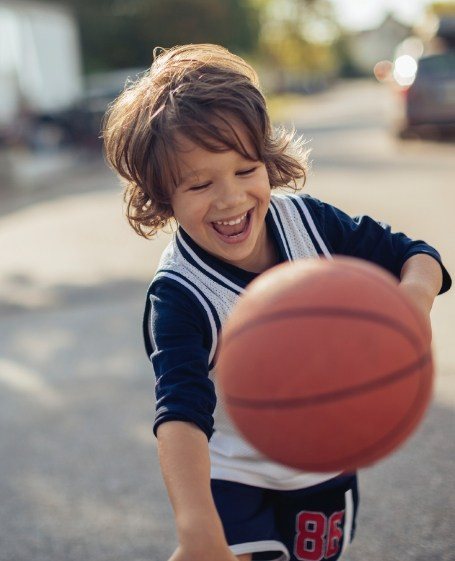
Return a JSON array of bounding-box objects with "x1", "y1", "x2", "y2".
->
[{"x1": 212, "y1": 475, "x2": 358, "y2": 561}]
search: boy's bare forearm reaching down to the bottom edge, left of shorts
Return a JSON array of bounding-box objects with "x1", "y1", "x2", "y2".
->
[{"x1": 157, "y1": 421, "x2": 236, "y2": 561}]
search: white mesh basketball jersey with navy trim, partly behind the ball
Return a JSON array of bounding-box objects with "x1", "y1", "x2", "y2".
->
[{"x1": 155, "y1": 195, "x2": 336, "y2": 489}]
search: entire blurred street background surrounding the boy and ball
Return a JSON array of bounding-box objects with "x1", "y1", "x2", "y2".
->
[{"x1": 0, "y1": 0, "x2": 455, "y2": 561}]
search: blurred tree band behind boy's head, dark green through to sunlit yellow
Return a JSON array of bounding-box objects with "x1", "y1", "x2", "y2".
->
[{"x1": 33, "y1": 0, "x2": 352, "y2": 80}]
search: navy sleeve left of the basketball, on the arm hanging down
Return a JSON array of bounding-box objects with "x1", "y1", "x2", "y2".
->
[{"x1": 144, "y1": 282, "x2": 216, "y2": 439}]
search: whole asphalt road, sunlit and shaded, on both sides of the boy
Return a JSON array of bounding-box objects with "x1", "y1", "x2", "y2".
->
[{"x1": 0, "y1": 83, "x2": 455, "y2": 561}]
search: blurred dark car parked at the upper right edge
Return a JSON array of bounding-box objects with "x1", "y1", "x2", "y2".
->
[{"x1": 398, "y1": 51, "x2": 455, "y2": 138}]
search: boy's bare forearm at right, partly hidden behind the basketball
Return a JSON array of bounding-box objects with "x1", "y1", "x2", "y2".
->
[{"x1": 399, "y1": 253, "x2": 442, "y2": 332}]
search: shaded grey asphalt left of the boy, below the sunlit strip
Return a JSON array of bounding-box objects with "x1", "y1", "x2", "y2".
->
[{"x1": 0, "y1": 282, "x2": 174, "y2": 561}]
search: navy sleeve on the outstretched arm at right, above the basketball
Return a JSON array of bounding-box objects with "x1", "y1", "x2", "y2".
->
[{"x1": 305, "y1": 197, "x2": 452, "y2": 294}]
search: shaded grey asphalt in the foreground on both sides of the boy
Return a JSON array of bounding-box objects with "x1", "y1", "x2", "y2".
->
[{"x1": 0, "y1": 282, "x2": 455, "y2": 561}]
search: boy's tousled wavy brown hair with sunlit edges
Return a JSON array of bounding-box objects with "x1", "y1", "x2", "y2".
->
[{"x1": 103, "y1": 44, "x2": 307, "y2": 237}]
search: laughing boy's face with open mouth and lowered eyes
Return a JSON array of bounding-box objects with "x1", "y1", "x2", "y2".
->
[{"x1": 171, "y1": 126, "x2": 273, "y2": 272}]
